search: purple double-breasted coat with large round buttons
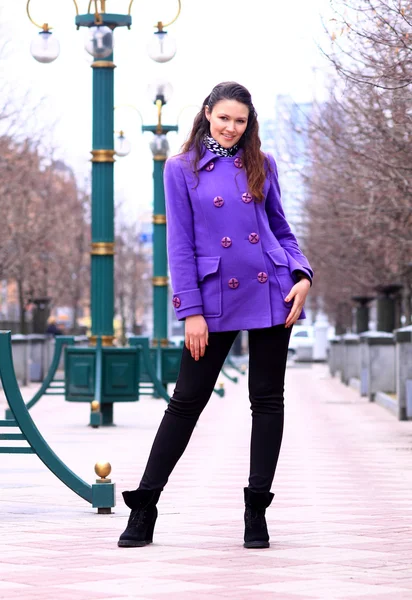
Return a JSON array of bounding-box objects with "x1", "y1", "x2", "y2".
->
[{"x1": 164, "y1": 150, "x2": 313, "y2": 332}]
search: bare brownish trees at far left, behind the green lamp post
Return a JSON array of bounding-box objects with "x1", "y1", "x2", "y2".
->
[{"x1": 0, "y1": 136, "x2": 89, "y2": 332}]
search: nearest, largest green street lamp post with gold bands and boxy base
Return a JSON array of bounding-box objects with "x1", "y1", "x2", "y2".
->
[{"x1": 26, "y1": 0, "x2": 180, "y2": 425}]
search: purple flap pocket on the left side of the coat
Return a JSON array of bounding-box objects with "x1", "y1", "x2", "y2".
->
[{"x1": 196, "y1": 256, "x2": 222, "y2": 317}]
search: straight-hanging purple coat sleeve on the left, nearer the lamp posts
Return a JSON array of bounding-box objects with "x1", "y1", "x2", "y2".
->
[{"x1": 164, "y1": 157, "x2": 203, "y2": 320}]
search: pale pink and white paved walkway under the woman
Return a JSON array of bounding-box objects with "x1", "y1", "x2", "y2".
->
[{"x1": 0, "y1": 365, "x2": 412, "y2": 600}]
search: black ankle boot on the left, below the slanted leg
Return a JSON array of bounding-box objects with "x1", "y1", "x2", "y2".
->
[{"x1": 117, "y1": 490, "x2": 161, "y2": 548}]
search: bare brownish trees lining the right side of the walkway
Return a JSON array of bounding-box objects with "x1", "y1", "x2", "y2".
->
[{"x1": 305, "y1": 0, "x2": 412, "y2": 328}]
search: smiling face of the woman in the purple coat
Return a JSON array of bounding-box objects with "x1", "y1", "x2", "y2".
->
[{"x1": 205, "y1": 100, "x2": 249, "y2": 148}]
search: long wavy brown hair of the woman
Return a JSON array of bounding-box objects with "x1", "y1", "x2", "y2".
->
[{"x1": 182, "y1": 81, "x2": 270, "y2": 202}]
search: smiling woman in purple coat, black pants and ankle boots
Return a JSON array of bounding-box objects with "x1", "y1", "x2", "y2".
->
[{"x1": 118, "y1": 82, "x2": 313, "y2": 548}]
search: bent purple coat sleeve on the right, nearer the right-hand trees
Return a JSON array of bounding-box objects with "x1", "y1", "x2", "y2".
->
[{"x1": 266, "y1": 154, "x2": 313, "y2": 283}]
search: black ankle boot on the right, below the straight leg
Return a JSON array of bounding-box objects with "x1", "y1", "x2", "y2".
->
[{"x1": 243, "y1": 488, "x2": 274, "y2": 548}]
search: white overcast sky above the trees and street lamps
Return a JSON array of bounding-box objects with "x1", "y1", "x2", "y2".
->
[{"x1": 0, "y1": 0, "x2": 329, "y2": 223}]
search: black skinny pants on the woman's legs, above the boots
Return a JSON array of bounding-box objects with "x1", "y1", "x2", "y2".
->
[{"x1": 139, "y1": 325, "x2": 291, "y2": 492}]
